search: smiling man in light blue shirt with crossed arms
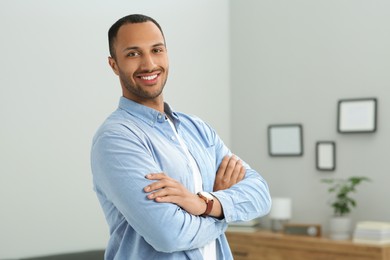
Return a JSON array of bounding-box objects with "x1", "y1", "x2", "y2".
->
[{"x1": 91, "y1": 15, "x2": 270, "y2": 260}]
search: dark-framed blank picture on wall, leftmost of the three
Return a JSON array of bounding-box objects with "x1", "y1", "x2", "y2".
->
[{"x1": 268, "y1": 124, "x2": 303, "y2": 156}]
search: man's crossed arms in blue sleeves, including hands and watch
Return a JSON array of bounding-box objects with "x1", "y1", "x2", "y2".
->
[{"x1": 92, "y1": 119, "x2": 270, "y2": 252}]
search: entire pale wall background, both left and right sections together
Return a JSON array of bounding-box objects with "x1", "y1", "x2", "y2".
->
[{"x1": 0, "y1": 0, "x2": 390, "y2": 258}]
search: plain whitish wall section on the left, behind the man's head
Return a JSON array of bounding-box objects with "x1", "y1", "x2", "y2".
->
[{"x1": 0, "y1": 0, "x2": 230, "y2": 259}]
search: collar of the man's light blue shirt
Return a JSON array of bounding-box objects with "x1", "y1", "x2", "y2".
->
[{"x1": 119, "y1": 96, "x2": 180, "y2": 127}]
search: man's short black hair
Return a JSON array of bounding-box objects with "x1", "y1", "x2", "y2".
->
[{"x1": 108, "y1": 14, "x2": 165, "y2": 59}]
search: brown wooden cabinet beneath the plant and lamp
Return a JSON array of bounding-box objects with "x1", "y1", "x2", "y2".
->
[{"x1": 226, "y1": 231, "x2": 390, "y2": 260}]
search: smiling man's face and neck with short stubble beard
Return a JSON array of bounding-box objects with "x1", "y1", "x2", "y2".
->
[{"x1": 109, "y1": 22, "x2": 169, "y2": 105}]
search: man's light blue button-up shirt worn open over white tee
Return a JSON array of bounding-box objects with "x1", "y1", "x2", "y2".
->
[{"x1": 91, "y1": 97, "x2": 271, "y2": 260}]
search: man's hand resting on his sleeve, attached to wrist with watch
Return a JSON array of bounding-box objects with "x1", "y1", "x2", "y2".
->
[{"x1": 144, "y1": 173, "x2": 206, "y2": 216}]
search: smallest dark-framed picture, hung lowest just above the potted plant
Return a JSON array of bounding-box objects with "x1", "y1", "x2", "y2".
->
[{"x1": 316, "y1": 141, "x2": 336, "y2": 171}]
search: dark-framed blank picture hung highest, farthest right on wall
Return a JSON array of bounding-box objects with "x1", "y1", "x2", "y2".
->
[{"x1": 337, "y1": 98, "x2": 377, "y2": 133}]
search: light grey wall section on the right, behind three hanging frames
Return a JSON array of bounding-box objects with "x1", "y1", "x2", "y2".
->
[{"x1": 230, "y1": 0, "x2": 390, "y2": 230}]
